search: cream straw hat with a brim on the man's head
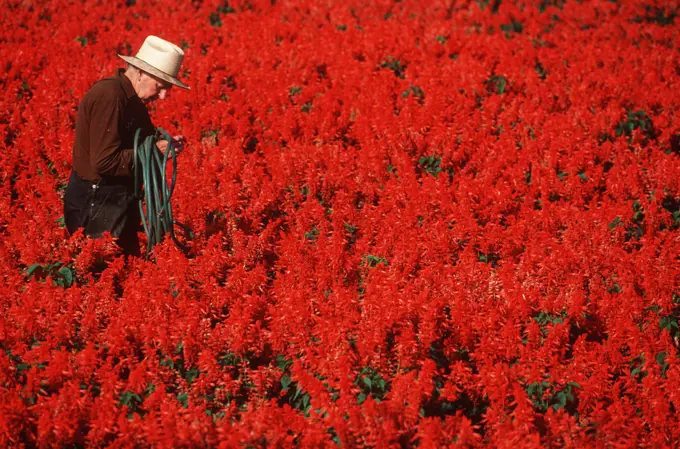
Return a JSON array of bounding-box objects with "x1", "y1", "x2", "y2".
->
[{"x1": 118, "y1": 36, "x2": 189, "y2": 89}]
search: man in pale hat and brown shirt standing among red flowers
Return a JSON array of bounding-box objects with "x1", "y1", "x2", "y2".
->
[{"x1": 64, "y1": 36, "x2": 189, "y2": 256}]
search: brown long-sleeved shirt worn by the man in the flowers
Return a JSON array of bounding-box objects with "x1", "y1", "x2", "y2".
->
[{"x1": 73, "y1": 69, "x2": 155, "y2": 182}]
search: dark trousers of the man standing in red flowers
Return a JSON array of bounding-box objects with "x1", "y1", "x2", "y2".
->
[{"x1": 64, "y1": 171, "x2": 142, "y2": 256}]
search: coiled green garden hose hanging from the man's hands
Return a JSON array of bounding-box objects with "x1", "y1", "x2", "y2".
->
[{"x1": 134, "y1": 128, "x2": 193, "y2": 256}]
